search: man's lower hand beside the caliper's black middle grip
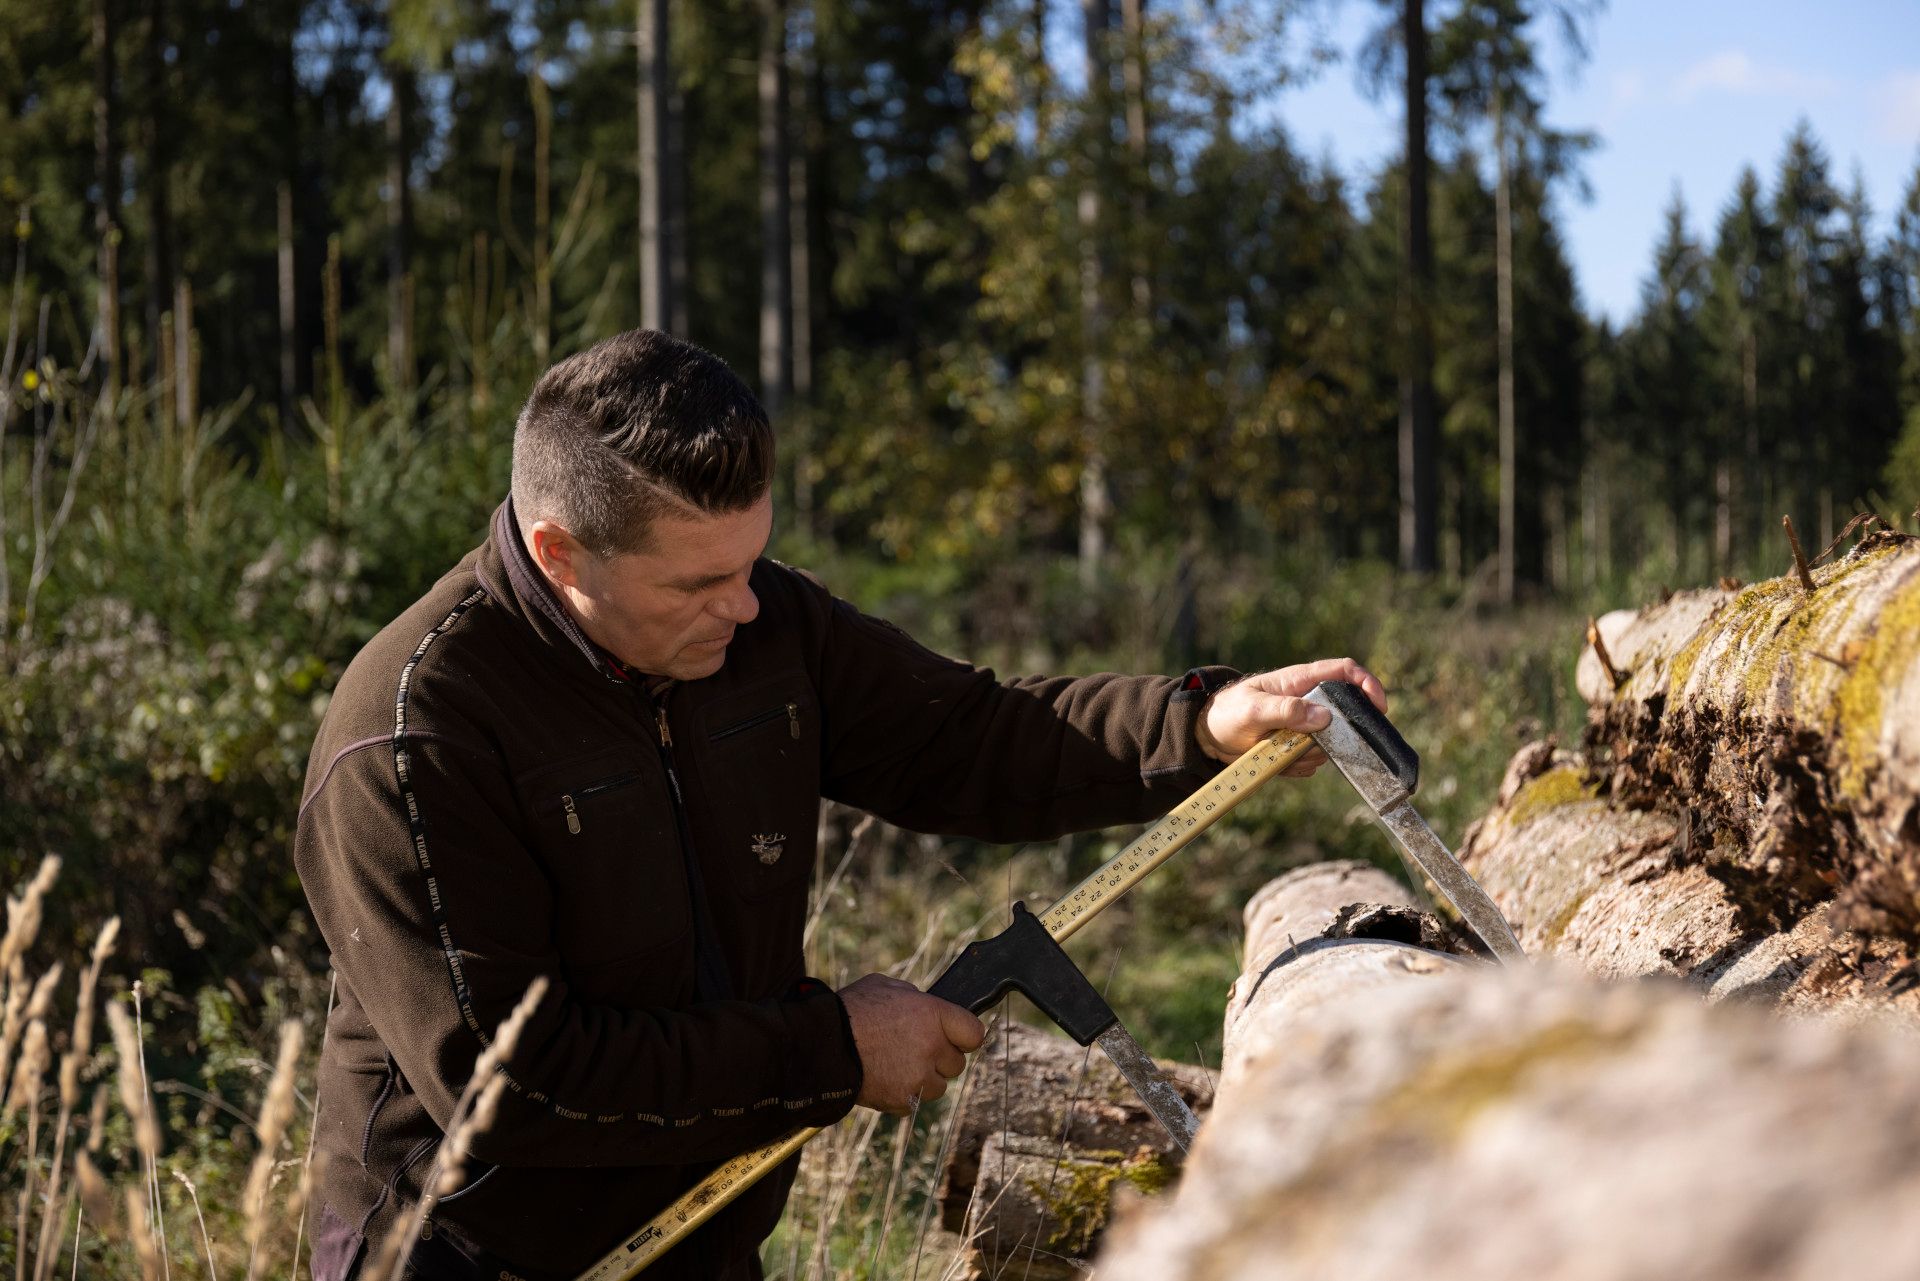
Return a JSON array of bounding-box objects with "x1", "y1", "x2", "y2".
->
[{"x1": 839, "y1": 974, "x2": 987, "y2": 1116}]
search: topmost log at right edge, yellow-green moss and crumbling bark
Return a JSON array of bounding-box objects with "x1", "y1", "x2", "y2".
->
[{"x1": 1576, "y1": 532, "x2": 1920, "y2": 939}]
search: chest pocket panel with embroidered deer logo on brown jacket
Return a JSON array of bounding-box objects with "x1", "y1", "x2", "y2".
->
[{"x1": 701, "y1": 678, "x2": 820, "y2": 901}]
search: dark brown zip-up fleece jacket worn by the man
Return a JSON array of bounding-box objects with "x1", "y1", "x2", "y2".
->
[{"x1": 294, "y1": 505, "x2": 1223, "y2": 1281}]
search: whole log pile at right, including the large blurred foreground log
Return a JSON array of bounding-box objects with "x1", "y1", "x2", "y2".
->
[{"x1": 1098, "y1": 534, "x2": 1920, "y2": 1281}]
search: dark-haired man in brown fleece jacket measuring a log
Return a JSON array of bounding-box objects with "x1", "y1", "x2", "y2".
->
[{"x1": 296, "y1": 330, "x2": 1384, "y2": 1281}]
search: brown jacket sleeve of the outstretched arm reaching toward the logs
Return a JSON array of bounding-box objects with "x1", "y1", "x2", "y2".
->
[{"x1": 808, "y1": 584, "x2": 1235, "y2": 841}]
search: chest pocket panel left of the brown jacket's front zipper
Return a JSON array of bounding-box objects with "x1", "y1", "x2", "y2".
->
[{"x1": 522, "y1": 753, "x2": 693, "y2": 981}]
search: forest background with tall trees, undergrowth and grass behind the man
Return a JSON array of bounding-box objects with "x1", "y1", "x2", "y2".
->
[{"x1": 0, "y1": 0, "x2": 1920, "y2": 1281}]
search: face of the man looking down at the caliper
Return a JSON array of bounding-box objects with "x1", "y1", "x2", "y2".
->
[{"x1": 532, "y1": 495, "x2": 774, "y2": 680}]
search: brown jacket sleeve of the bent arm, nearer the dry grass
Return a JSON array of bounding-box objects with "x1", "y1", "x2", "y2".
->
[{"x1": 296, "y1": 737, "x2": 860, "y2": 1166}]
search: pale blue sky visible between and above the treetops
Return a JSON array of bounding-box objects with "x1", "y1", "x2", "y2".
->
[{"x1": 1273, "y1": 0, "x2": 1920, "y2": 321}]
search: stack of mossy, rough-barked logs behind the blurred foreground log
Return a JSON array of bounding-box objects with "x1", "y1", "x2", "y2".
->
[{"x1": 1461, "y1": 534, "x2": 1920, "y2": 1018}]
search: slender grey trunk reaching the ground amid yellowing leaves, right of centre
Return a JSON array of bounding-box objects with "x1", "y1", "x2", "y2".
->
[{"x1": 1079, "y1": 0, "x2": 1114, "y2": 588}]
